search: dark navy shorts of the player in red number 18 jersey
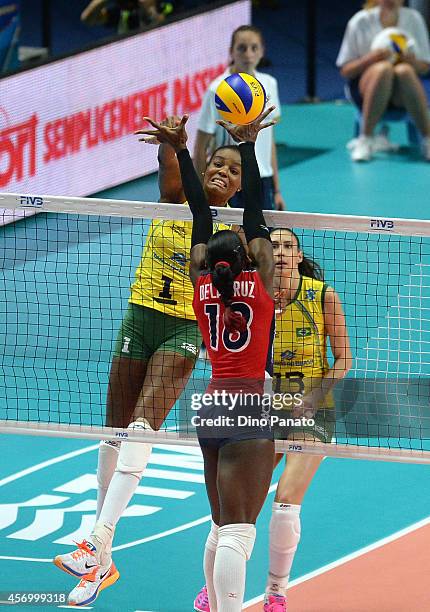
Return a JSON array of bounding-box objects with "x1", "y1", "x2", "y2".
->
[{"x1": 192, "y1": 379, "x2": 273, "y2": 448}]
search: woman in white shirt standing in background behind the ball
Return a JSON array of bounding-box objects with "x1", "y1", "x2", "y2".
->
[{"x1": 194, "y1": 25, "x2": 285, "y2": 210}]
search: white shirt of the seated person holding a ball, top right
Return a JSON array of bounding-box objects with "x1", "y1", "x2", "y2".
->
[{"x1": 336, "y1": 6, "x2": 430, "y2": 68}]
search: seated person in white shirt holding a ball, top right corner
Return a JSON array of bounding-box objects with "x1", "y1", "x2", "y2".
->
[{"x1": 336, "y1": 0, "x2": 430, "y2": 161}]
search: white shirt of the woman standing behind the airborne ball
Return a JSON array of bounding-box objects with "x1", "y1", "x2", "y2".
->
[{"x1": 197, "y1": 69, "x2": 281, "y2": 178}]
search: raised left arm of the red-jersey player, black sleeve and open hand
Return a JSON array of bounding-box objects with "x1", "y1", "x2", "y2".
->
[{"x1": 136, "y1": 115, "x2": 213, "y2": 284}]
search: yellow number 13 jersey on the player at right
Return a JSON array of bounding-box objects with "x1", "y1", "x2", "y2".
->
[{"x1": 273, "y1": 276, "x2": 333, "y2": 407}]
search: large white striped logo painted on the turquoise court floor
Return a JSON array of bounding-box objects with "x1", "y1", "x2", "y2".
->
[{"x1": 0, "y1": 438, "x2": 210, "y2": 562}]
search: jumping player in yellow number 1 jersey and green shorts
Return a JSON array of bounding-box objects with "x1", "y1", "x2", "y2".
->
[{"x1": 54, "y1": 118, "x2": 241, "y2": 606}]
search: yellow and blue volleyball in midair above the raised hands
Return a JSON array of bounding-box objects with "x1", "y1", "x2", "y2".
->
[{"x1": 215, "y1": 72, "x2": 266, "y2": 125}]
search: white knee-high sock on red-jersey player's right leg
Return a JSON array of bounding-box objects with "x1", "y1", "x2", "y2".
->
[{"x1": 213, "y1": 523, "x2": 255, "y2": 612}]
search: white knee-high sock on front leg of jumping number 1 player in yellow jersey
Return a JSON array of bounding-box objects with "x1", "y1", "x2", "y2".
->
[{"x1": 99, "y1": 441, "x2": 152, "y2": 527}]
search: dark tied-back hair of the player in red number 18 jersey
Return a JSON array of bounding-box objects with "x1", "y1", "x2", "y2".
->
[{"x1": 206, "y1": 230, "x2": 247, "y2": 332}]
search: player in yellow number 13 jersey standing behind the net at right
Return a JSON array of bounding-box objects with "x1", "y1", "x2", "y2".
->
[{"x1": 194, "y1": 229, "x2": 352, "y2": 612}]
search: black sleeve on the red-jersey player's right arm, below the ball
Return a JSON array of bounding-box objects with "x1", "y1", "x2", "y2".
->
[{"x1": 239, "y1": 142, "x2": 270, "y2": 243}]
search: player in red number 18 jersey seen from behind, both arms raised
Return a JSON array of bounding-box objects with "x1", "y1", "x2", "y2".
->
[{"x1": 136, "y1": 108, "x2": 274, "y2": 612}]
